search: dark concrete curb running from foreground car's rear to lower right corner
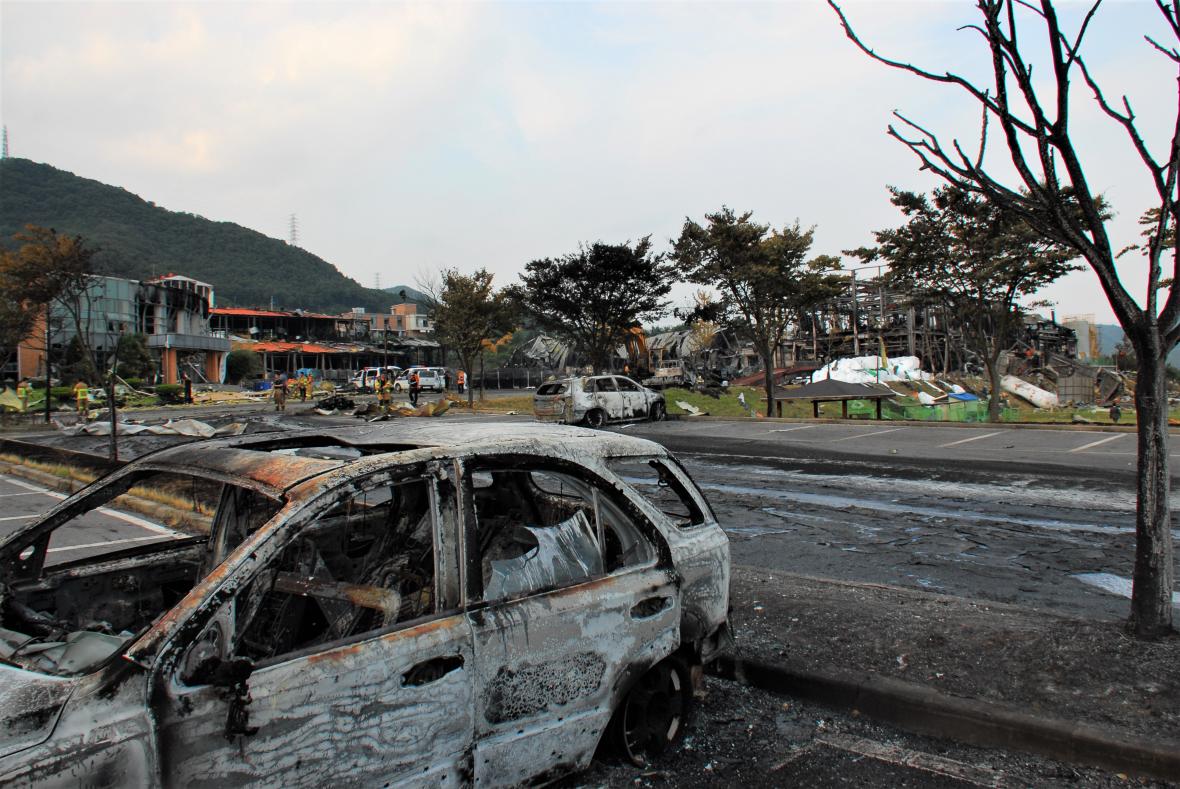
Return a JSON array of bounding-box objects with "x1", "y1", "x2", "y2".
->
[{"x1": 710, "y1": 656, "x2": 1180, "y2": 781}]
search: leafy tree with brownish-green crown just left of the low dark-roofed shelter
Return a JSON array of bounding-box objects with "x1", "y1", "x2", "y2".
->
[{"x1": 673, "y1": 206, "x2": 840, "y2": 414}]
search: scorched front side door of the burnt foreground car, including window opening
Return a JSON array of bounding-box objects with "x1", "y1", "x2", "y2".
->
[{"x1": 153, "y1": 473, "x2": 473, "y2": 787}]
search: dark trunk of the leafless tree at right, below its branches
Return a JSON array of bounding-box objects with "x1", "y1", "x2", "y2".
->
[{"x1": 1127, "y1": 329, "x2": 1174, "y2": 638}]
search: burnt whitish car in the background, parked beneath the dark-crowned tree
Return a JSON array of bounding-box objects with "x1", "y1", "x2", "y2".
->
[{"x1": 532, "y1": 375, "x2": 668, "y2": 427}]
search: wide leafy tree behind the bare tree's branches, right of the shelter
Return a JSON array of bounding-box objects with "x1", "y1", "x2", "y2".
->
[{"x1": 847, "y1": 186, "x2": 1079, "y2": 422}]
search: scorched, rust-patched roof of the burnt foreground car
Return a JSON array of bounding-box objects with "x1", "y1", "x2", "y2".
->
[{"x1": 131, "y1": 419, "x2": 666, "y2": 494}]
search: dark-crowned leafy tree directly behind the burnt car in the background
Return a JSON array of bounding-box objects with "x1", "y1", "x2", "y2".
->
[{"x1": 511, "y1": 236, "x2": 675, "y2": 370}]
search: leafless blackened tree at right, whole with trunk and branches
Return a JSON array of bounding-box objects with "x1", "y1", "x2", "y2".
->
[{"x1": 828, "y1": 0, "x2": 1180, "y2": 638}]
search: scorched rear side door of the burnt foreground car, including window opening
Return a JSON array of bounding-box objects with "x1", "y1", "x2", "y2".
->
[{"x1": 463, "y1": 458, "x2": 680, "y2": 785}]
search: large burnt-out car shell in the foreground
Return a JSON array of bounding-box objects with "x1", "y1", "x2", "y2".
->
[{"x1": 0, "y1": 422, "x2": 729, "y2": 787}]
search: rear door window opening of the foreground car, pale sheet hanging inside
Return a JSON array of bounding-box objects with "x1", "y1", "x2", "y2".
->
[{"x1": 471, "y1": 467, "x2": 655, "y2": 603}]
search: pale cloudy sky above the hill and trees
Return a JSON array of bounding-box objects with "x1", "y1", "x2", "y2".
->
[{"x1": 0, "y1": 0, "x2": 1176, "y2": 322}]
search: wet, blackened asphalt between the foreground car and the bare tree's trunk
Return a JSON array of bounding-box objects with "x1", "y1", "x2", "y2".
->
[{"x1": 616, "y1": 421, "x2": 1180, "y2": 619}]
